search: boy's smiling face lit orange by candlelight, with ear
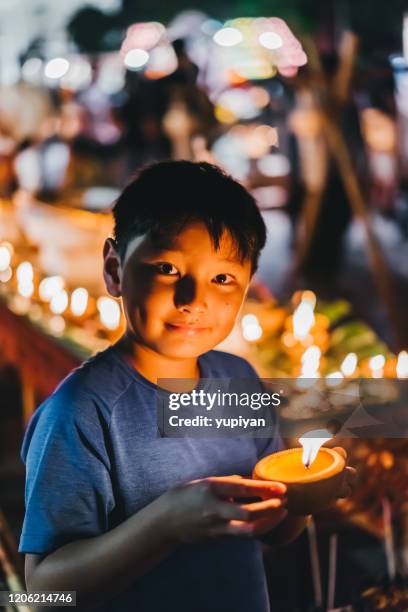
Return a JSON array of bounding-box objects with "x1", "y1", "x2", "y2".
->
[{"x1": 104, "y1": 222, "x2": 251, "y2": 358}]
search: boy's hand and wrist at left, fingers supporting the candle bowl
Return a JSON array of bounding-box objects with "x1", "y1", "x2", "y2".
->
[{"x1": 161, "y1": 476, "x2": 287, "y2": 542}]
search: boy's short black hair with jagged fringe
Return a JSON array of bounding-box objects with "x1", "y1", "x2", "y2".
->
[{"x1": 113, "y1": 161, "x2": 266, "y2": 274}]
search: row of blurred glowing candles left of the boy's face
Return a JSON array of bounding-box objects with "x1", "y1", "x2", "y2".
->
[{"x1": 0, "y1": 242, "x2": 122, "y2": 335}]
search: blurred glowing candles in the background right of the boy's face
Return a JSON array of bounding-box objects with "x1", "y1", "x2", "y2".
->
[{"x1": 241, "y1": 291, "x2": 408, "y2": 387}]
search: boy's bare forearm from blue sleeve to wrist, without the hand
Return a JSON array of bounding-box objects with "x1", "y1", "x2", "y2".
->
[{"x1": 26, "y1": 498, "x2": 176, "y2": 610}]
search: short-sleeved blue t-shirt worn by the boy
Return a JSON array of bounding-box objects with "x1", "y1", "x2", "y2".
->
[{"x1": 19, "y1": 346, "x2": 283, "y2": 612}]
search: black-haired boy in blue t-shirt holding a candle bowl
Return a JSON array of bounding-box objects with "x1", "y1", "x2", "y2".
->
[{"x1": 19, "y1": 161, "x2": 354, "y2": 612}]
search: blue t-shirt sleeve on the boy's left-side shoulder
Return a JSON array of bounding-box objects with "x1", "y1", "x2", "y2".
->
[{"x1": 18, "y1": 392, "x2": 115, "y2": 553}]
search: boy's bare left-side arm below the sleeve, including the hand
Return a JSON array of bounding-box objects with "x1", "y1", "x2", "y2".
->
[{"x1": 27, "y1": 476, "x2": 283, "y2": 610}]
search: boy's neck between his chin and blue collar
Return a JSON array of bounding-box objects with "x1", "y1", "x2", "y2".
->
[{"x1": 116, "y1": 334, "x2": 200, "y2": 385}]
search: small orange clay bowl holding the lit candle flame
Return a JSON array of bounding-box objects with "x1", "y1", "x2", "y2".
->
[{"x1": 252, "y1": 447, "x2": 346, "y2": 514}]
